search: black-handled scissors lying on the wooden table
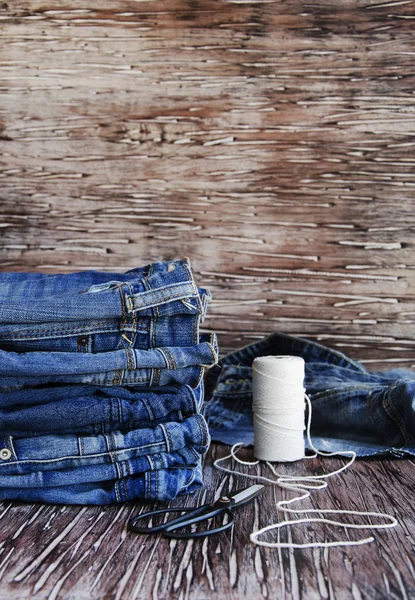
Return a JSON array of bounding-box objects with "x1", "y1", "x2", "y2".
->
[{"x1": 127, "y1": 485, "x2": 264, "y2": 540}]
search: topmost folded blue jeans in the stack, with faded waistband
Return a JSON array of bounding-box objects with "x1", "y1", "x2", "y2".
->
[{"x1": 0, "y1": 259, "x2": 210, "y2": 324}]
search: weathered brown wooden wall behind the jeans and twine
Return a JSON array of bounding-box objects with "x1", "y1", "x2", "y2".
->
[{"x1": 0, "y1": 0, "x2": 415, "y2": 368}]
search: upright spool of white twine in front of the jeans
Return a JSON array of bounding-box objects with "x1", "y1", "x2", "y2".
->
[{"x1": 252, "y1": 356, "x2": 305, "y2": 462}]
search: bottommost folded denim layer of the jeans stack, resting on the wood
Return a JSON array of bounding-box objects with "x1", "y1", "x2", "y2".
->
[{"x1": 0, "y1": 464, "x2": 203, "y2": 504}]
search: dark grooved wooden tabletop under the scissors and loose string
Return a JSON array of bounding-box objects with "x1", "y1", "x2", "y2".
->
[{"x1": 0, "y1": 444, "x2": 415, "y2": 600}]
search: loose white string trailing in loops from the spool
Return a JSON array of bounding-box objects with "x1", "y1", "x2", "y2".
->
[{"x1": 213, "y1": 356, "x2": 398, "y2": 548}]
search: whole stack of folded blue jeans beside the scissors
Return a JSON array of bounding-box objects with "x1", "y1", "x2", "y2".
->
[{"x1": 0, "y1": 259, "x2": 218, "y2": 504}]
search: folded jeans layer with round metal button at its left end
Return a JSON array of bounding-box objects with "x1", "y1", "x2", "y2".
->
[{"x1": 0, "y1": 414, "x2": 210, "y2": 474}]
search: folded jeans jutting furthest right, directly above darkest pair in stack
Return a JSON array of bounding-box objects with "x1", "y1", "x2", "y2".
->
[{"x1": 0, "y1": 334, "x2": 218, "y2": 390}]
